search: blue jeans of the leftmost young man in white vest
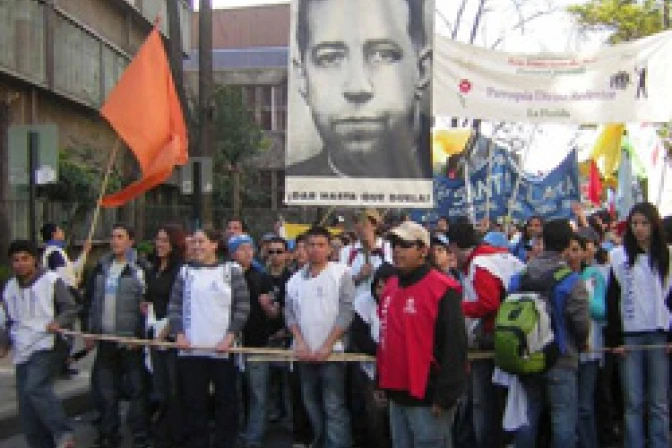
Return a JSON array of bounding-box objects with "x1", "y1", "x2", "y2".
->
[{"x1": 16, "y1": 350, "x2": 72, "y2": 448}]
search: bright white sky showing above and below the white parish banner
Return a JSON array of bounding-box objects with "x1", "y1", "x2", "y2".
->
[{"x1": 194, "y1": 0, "x2": 604, "y2": 173}]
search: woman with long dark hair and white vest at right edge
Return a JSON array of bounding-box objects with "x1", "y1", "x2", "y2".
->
[{"x1": 606, "y1": 202, "x2": 672, "y2": 448}]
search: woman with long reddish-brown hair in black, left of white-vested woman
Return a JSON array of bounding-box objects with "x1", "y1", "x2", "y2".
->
[{"x1": 145, "y1": 225, "x2": 186, "y2": 448}]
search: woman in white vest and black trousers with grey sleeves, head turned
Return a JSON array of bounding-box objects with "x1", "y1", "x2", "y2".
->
[{"x1": 168, "y1": 230, "x2": 250, "y2": 448}]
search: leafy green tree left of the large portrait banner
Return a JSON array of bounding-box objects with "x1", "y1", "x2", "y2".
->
[{"x1": 213, "y1": 86, "x2": 269, "y2": 214}]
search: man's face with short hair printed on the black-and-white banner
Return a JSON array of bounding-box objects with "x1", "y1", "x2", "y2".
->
[{"x1": 299, "y1": 0, "x2": 423, "y2": 160}]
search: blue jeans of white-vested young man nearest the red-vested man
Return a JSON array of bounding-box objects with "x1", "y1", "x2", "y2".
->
[{"x1": 299, "y1": 363, "x2": 352, "y2": 448}]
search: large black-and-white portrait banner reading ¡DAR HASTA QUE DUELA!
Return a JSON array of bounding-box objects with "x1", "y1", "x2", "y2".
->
[{"x1": 285, "y1": 0, "x2": 434, "y2": 208}]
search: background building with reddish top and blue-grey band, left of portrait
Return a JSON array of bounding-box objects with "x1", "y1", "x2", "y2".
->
[{"x1": 184, "y1": 4, "x2": 290, "y2": 212}]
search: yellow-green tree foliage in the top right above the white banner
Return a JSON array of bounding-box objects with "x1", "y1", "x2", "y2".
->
[{"x1": 567, "y1": 0, "x2": 667, "y2": 44}]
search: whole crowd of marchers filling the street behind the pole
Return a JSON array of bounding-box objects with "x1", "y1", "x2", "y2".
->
[{"x1": 0, "y1": 203, "x2": 672, "y2": 448}]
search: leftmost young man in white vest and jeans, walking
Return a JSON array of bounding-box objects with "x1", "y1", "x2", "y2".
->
[{"x1": 0, "y1": 240, "x2": 77, "y2": 448}]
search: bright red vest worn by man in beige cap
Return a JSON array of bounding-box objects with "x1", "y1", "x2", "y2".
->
[{"x1": 377, "y1": 269, "x2": 459, "y2": 400}]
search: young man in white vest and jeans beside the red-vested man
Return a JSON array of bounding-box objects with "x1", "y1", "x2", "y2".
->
[{"x1": 285, "y1": 227, "x2": 355, "y2": 448}]
